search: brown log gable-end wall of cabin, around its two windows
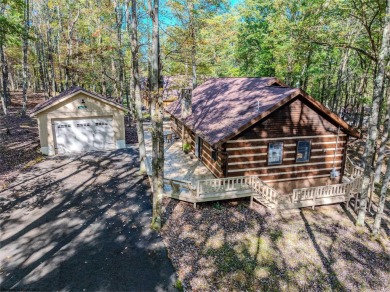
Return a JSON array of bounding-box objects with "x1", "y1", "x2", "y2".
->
[{"x1": 223, "y1": 98, "x2": 348, "y2": 191}]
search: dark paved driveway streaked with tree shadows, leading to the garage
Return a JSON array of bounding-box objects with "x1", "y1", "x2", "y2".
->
[{"x1": 0, "y1": 149, "x2": 176, "y2": 291}]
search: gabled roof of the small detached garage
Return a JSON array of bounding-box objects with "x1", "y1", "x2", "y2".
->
[{"x1": 31, "y1": 86, "x2": 127, "y2": 116}]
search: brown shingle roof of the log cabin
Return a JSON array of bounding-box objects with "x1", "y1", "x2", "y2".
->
[{"x1": 167, "y1": 77, "x2": 359, "y2": 145}]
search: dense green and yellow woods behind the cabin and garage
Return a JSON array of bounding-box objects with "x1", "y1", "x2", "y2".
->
[{"x1": 0, "y1": 0, "x2": 389, "y2": 118}]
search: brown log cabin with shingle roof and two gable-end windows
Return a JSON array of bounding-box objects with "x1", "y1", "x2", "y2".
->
[{"x1": 166, "y1": 77, "x2": 360, "y2": 193}]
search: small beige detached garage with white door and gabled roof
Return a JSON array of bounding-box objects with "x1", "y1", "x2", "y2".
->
[{"x1": 31, "y1": 87, "x2": 126, "y2": 155}]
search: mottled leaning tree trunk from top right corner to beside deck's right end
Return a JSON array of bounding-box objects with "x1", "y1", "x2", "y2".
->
[{"x1": 356, "y1": 0, "x2": 390, "y2": 226}]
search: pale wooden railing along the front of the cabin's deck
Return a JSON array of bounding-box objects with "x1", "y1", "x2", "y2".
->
[{"x1": 146, "y1": 158, "x2": 363, "y2": 210}]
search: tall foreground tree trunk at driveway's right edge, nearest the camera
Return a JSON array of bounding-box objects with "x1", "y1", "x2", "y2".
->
[{"x1": 148, "y1": 0, "x2": 164, "y2": 230}]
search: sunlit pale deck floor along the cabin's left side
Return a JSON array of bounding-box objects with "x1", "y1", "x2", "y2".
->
[{"x1": 145, "y1": 128, "x2": 215, "y2": 183}]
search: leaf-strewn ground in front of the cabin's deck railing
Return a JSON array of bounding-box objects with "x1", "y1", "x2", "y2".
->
[{"x1": 162, "y1": 199, "x2": 390, "y2": 291}]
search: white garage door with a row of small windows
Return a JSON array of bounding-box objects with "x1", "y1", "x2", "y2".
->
[{"x1": 54, "y1": 118, "x2": 115, "y2": 154}]
